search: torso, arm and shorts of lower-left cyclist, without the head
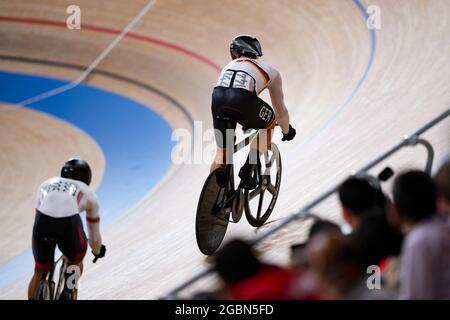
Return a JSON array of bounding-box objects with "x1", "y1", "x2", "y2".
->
[{"x1": 33, "y1": 177, "x2": 101, "y2": 265}]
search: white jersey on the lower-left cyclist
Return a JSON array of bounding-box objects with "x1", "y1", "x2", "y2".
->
[{"x1": 36, "y1": 177, "x2": 101, "y2": 240}]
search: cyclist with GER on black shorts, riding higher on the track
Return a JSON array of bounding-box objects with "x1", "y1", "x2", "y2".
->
[{"x1": 211, "y1": 35, "x2": 296, "y2": 189}]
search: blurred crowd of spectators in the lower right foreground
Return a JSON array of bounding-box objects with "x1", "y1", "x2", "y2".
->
[{"x1": 193, "y1": 160, "x2": 450, "y2": 300}]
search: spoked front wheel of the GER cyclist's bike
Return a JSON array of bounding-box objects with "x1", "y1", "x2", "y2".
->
[{"x1": 244, "y1": 143, "x2": 281, "y2": 228}]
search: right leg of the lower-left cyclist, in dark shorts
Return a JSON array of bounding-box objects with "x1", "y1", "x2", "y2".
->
[{"x1": 58, "y1": 214, "x2": 87, "y2": 289}]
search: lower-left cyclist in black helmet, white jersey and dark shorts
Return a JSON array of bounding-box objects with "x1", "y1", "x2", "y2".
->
[{"x1": 28, "y1": 159, "x2": 106, "y2": 299}]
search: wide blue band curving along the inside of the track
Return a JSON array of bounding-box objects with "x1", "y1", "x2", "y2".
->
[{"x1": 0, "y1": 71, "x2": 174, "y2": 288}]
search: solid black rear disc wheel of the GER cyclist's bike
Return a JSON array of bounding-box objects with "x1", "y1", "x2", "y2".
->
[{"x1": 195, "y1": 169, "x2": 230, "y2": 255}]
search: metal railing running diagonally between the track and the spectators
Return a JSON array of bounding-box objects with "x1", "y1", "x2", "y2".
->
[{"x1": 165, "y1": 108, "x2": 450, "y2": 299}]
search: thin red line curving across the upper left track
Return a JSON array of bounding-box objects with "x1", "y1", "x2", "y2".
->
[{"x1": 0, "y1": 16, "x2": 221, "y2": 71}]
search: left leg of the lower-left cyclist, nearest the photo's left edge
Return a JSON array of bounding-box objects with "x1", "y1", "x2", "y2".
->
[{"x1": 28, "y1": 212, "x2": 56, "y2": 299}]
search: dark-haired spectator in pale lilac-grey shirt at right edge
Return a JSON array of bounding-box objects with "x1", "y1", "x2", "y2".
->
[{"x1": 390, "y1": 170, "x2": 450, "y2": 299}]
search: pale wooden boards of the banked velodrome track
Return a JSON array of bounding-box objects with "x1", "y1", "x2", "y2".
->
[{"x1": 0, "y1": 0, "x2": 450, "y2": 299}]
